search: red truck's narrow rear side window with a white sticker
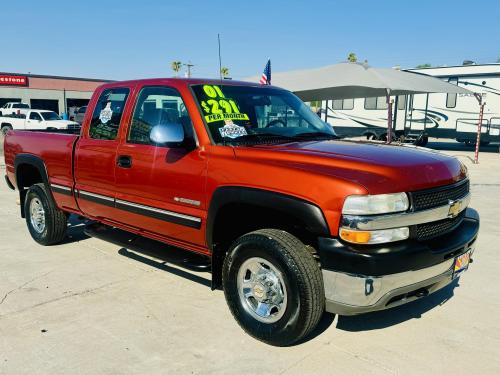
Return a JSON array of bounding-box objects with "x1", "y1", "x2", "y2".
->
[{"x1": 89, "y1": 87, "x2": 130, "y2": 140}]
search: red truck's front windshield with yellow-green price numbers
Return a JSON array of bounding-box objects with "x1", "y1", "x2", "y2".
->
[{"x1": 192, "y1": 84, "x2": 336, "y2": 144}]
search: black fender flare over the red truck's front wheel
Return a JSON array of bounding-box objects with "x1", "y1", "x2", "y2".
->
[{"x1": 206, "y1": 186, "x2": 330, "y2": 251}]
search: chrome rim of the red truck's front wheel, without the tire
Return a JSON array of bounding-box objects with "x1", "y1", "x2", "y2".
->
[{"x1": 237, "y1": 257, "x2": 287, "y2": 323}]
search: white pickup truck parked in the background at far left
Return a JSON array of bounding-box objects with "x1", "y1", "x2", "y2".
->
[{"x1": 0, "y1": 110, "x2": 80, "y2": 135}]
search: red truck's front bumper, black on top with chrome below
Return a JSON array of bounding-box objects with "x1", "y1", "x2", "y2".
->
[{"x1": 319, "y1": 208, "x2": 479, "y2": 315}]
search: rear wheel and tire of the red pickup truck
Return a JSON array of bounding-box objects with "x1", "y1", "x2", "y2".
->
[{"x1": 24, "y1": 184, "x2": 67, "y2": 246}]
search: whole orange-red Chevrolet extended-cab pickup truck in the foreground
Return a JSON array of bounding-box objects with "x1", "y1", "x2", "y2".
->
[{"x1": 4, "y1": 79, "x2": 479, "y2": 345}]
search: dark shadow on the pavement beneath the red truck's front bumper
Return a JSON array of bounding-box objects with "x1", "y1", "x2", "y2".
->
[{"x1": 337, "y1": 279, "x2": 460, "y2": 332}]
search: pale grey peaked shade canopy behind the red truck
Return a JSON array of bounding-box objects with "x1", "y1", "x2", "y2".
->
[{"x1": 262, "y1": 62, "x2": 473, "y2": 101}]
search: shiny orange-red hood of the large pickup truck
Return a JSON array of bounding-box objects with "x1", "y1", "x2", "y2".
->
[{"x1": 235, "y1": 141, "x2": 467, "y2": 194}]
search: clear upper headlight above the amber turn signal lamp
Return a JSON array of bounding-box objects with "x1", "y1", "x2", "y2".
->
[{"x1": 342, "y1": 193, "x2": 410, "y2": 215}]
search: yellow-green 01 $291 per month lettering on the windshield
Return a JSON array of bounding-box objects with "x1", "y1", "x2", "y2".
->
[{"x1": 200, "y1": 85, "x2": 249, "y2": 123}]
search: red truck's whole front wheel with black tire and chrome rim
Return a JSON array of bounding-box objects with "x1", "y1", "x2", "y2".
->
[{"x1": 222, "y1": 229, "x2": 325, "y2": 346}]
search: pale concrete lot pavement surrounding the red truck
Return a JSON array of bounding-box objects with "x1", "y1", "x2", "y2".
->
[{"x1": 0, "y1": 142, "x2": 500, "y2": 374}]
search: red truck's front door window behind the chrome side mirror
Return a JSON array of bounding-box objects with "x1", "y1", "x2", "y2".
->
[{"x1": 127, "y1": 86, "x2": 193, "y2": 145}]
